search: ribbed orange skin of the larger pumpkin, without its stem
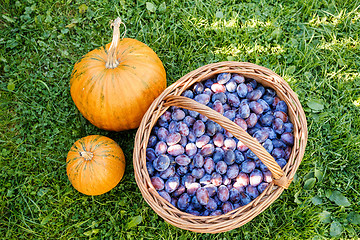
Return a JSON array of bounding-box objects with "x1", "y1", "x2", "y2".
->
[{"x1": 70, "y1": 38, "x2": 166, "y2": 131}]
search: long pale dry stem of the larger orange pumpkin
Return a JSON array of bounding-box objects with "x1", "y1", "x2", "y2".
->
[{"x1": 105, "y1": 17, "x2": 126, "y2": 69}]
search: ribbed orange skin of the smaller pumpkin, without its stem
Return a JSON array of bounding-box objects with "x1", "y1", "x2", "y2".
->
[{"x1": 66, "y1": 135, "x2": 125, "y2": 195}]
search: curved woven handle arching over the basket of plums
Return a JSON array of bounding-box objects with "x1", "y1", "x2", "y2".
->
[{"x1": 164, "y1": 95, "x2": 291, "y2": 189}]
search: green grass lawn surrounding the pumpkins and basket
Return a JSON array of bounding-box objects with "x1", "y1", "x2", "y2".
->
[{"x1": 0, "y1": 0, "x2": 360, "y2": 239}]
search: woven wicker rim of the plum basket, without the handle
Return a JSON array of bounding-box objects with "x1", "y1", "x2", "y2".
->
[{"x1": 133, "y1": 61, "x2": 307, "y2": 233}]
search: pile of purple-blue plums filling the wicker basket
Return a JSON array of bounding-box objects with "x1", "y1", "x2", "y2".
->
[{"x1": 146, "y1": 73, "x2": 294, "y2": 216}]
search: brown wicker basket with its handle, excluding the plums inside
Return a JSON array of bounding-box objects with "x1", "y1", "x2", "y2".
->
[{"x1": 133, "y1": 62, "x2": 307, "y2": 233}]
